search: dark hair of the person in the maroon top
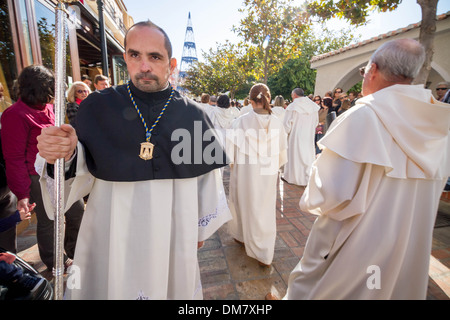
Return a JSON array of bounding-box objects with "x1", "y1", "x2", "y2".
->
[{"x1": 17, "y1": 65, "x2": 55, "y2": 106}]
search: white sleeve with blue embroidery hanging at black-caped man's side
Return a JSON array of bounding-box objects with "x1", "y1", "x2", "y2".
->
[{"x1": 198, "y1": 169, "x2": 231, "y2": 241}]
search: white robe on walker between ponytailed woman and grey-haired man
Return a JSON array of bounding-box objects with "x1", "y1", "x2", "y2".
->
[{"x1": 283, "y1": 97, "x2": 320, "y2": 186}]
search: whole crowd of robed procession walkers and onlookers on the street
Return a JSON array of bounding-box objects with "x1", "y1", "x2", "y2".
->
[{"x1": 0, "y1": 21, "x2": 450, "y2": 299}]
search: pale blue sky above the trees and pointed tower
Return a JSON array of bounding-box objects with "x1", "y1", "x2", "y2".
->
[{"x1": 123, "y1": 0, "x2": 450, "y2": 65}]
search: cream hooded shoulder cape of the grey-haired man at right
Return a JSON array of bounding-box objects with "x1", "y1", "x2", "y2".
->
[{"x1": 318, "y1": 85, "x2": 450, "y2": 179}]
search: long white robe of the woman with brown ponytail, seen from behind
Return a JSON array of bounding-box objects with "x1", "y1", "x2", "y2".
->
[{"x1": 226, "y1": 111, "x2": 287, "y2": 265}]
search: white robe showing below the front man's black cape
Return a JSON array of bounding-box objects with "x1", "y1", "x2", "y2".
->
[{"x1": 36, "y1": 144, "x2": 231, "y2": 300}]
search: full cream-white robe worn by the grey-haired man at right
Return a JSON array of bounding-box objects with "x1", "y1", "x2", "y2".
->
[{"x1": 285, "y1": 85, "x2": 450, "y2": 300}]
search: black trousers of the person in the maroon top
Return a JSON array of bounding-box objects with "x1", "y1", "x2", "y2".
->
[{"x1": 30, "y1": 176, "x2": 84, "y2": 270}]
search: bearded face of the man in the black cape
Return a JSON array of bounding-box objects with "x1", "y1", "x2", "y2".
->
[{"x1": 124, "y1": 26, "x2": 176, "y2": 92}]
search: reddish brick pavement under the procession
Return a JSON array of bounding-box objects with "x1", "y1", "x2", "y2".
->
[{"x1": 18, "y1": 170, "x2": 450, "y2": 300}]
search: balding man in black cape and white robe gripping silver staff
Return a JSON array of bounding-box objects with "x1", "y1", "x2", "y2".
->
[{"x1": 36, "y1": 21, "x2": 231, "y2": 300}]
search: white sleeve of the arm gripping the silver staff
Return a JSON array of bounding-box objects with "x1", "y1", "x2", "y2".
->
[{"x1": 35, "y1": 142, "x2": 95, "y2": 220}]
